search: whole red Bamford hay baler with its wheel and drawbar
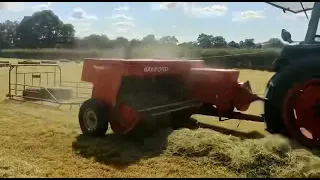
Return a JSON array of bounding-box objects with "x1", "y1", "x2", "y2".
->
[{"x1": 79, "y1": 59, "x2": 264, "y2": 135}]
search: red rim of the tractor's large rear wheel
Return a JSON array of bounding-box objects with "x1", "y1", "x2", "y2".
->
[{"x1": 283, "y1": 79, "x2": 320, "y2": 145}]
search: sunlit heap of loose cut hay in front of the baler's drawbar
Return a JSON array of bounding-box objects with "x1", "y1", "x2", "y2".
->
[{"x1": 159, "y1": 129, "x2": 320, "y2": 177}]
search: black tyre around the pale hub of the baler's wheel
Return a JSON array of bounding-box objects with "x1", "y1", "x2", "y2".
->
[{"x1": 78, "y1": 99, "x2": 109, "y2": 136}]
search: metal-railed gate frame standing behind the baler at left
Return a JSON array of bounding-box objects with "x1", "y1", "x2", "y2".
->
[{"x1": 7, "y1": 64, "x2": 92, "y2": 108}]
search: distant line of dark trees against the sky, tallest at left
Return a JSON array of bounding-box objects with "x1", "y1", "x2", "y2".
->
[{"x1": 0, "y1": 10, "x2": 283, "y2": 49}]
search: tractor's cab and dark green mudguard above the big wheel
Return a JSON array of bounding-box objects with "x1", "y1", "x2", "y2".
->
[{"x1": 267, "y1": 2, "x2": 320, "y2": 72}]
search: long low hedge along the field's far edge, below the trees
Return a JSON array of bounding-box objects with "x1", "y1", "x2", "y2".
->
[{"x1": 0, "y1": 47, "x2": 280, "y2": 71}]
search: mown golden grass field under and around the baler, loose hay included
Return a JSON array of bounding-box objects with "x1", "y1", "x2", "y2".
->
[{"x1": 0, "y1": 59, "x2": 320, "y2": 177}]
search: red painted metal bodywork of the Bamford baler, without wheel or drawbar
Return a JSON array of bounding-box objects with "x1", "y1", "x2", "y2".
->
[{"x1": 82, "y1": 59, "x2": 262, "y2": 133}]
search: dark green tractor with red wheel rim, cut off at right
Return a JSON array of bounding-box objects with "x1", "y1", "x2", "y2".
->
[{"x1": 264, "y1": 2, "x2": 320, "y2": 147}]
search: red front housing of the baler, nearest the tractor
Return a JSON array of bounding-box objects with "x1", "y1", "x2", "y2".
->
[{"x1": 188, "y1": 68, "x2": 263, "y2": 116}]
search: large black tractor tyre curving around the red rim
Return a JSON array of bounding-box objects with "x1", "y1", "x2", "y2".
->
[{"x1": 265, "y1": 58, "x2": 320, "y2": 145}]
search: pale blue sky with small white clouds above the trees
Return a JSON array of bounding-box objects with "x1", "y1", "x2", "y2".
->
[{"x1": 0, "y1": 2, "x2": 320, "y2": 42}]
